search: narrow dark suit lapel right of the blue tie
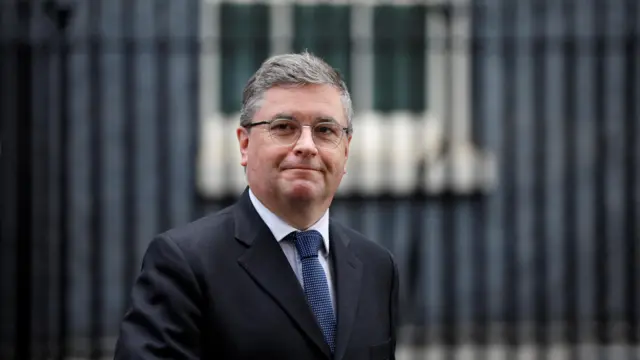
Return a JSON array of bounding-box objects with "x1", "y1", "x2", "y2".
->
[{"x1": 329, "y1": 221, "x2": 362, "y2": 360}]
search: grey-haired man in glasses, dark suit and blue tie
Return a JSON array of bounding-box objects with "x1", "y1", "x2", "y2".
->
[{"x1": 115, "y1": 53, "x2": 398, "y2": 360}]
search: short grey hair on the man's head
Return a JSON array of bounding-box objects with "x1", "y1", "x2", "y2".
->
[{"x1": 240, "y1": 51, "x2": 353, "y2": 130}]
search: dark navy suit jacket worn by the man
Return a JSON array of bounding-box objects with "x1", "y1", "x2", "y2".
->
[{"x1": 115, "y1": 190, "x2": 398, "y2": 360}]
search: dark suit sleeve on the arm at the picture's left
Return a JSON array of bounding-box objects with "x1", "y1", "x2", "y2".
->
[{"x1": 114, "y1": 236, "x2": 202, "y2": 360}]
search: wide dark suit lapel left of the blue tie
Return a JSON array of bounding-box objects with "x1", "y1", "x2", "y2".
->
[{"x1": 235, "y1": 191, "x2": 331, "y2": 357}]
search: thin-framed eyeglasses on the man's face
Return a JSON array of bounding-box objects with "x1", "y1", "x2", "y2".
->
[{"x1": 244, "y1": 119, "x2": 350, "y2": 148}]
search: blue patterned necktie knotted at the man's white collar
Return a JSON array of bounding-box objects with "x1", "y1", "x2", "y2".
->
[{"x1": 294, "y1": 230, "x2": 336, "y2": 352}]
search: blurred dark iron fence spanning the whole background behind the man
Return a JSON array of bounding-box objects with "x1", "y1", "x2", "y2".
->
[{"x1": 0, "y1": 0, "x2": 640, "y2": 359}]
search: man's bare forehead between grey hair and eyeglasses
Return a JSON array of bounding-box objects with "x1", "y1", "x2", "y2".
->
[{"x1": 256, "y1": 85, "x2": 347, "y2": 125}]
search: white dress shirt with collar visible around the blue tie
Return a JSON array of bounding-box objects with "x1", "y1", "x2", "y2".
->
[{"x1": 249, "y1": 189, "x2": 336, "y2": 313}]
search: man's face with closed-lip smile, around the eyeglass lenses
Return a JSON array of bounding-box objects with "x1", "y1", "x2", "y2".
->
[{"x1": 237, "y1": 85, "x2": 351, "y2": 202}]
